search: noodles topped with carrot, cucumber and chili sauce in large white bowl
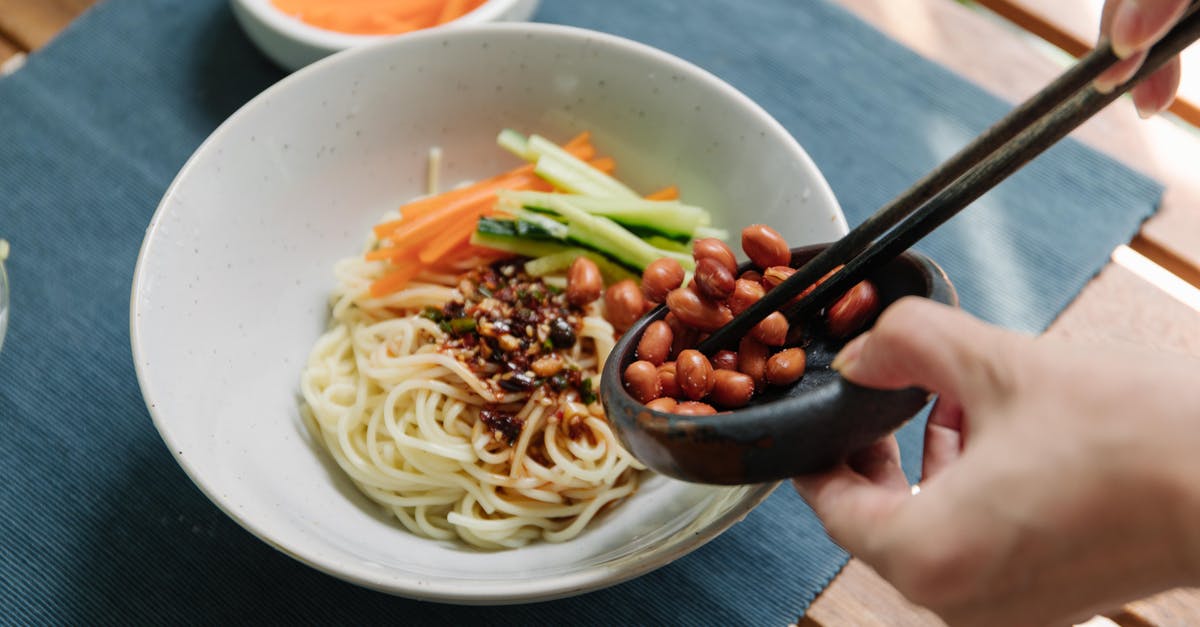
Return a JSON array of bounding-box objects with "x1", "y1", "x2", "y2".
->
[{"x1": 301, "y1": 131, "x2": 719, "y2": 549}]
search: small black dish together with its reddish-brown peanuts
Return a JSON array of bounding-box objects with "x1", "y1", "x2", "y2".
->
[{"x1": 600, "y1": 225, "x2": 958, "y2": 485}]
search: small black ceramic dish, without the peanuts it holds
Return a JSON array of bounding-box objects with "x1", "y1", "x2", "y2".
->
[{"x1": 600, "y1": 245, "x2": 958, "y2": 485}]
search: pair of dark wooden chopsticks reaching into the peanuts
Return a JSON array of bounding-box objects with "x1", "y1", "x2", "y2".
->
[{"x1": 698, "y1": 0, "x2": 1200, "y2": 354}]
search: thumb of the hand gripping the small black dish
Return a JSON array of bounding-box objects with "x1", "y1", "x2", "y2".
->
[{"x1": 833, "y1": 298, "x2": 1030, "y2": 405}]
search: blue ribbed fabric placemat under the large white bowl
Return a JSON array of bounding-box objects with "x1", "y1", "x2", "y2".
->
[{"x1": 0, "y1": 0, "x2": 1160, "y2": 625}]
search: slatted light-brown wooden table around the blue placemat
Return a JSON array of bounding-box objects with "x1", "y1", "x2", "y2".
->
[{"x1": 0, "y1": 0, "x2": 1200, "y2": 627}]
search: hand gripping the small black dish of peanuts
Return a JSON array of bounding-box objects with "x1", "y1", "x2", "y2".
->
[{"x1": 794, "y1": 298, "x2": 1200, "y2": 625}]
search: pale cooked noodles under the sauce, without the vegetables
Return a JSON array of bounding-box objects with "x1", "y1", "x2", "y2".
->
[{"x1": 301, "y1": 248, "x2": 642, "y2": 549}]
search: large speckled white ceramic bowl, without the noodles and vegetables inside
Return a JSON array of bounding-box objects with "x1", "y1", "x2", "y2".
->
[{"x1": 131, "y1": 24, "x2": 846, "y2": 603}]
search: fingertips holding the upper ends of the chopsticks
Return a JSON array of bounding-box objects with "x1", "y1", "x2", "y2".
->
[{"x1": 1096, "y1": 0, "x2": 1189, "y2": 118}]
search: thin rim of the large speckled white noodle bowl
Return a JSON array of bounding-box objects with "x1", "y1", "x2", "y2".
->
[{"x1": 130, "y1": 23, "x2": 846, "y2": 604}]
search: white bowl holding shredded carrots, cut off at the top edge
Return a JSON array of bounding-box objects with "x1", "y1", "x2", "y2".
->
[{"x1": 230, "y1": 0, "x2": 539, "y2": 71}]
